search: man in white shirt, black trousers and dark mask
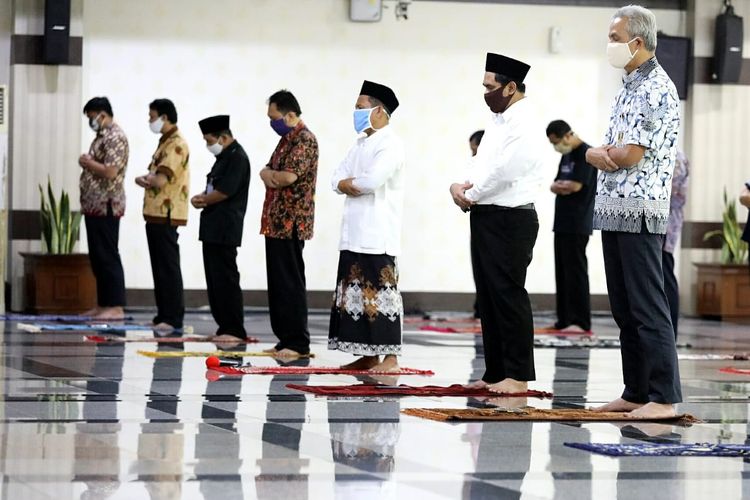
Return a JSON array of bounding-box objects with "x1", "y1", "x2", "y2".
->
[{"x1": 450, "y1": 53, "x2": 544, "y2": 394}]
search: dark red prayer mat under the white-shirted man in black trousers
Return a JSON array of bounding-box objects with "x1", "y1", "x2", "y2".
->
[{"x1": 286, "y1": 384, "x2": 552, "y2": 398}]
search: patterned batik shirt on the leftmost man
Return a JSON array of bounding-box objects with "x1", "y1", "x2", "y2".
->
[{"x1": 79, "y1": 123, "x2": 129, "y2": 217}]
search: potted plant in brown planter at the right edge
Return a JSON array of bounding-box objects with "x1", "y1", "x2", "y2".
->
[{"x1": 694, "y1": 189, "x2": 750, "y2": 318}]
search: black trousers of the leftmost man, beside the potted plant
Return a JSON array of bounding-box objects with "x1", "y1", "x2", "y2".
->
[{"x1": 84, "y1": 213, "x2": 125, "y2": 307}]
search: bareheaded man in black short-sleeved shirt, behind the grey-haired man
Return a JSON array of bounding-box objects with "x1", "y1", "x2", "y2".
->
[{"x1": 547, "y1": 120, "x2": 597, "y2": 331}]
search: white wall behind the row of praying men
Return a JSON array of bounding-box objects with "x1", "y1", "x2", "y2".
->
[{"x1": 78, "y1": 0, "x2": 684, "y2": 293}]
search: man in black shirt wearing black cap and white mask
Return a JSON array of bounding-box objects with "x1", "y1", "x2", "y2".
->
[{"x1": 190, "y1": 115, "x2": 250, "y2": 341}]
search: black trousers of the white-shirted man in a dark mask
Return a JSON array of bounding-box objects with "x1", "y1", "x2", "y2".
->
[{"x1": 471, "y1": 205, "x2": 539, "y2": 383}]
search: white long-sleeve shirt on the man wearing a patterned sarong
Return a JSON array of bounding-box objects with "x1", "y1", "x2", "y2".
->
[{"x1": 331, "y1": 126, "x2": 406, "y2": 256}]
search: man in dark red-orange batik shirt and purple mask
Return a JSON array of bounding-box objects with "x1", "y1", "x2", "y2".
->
[{"x1": 260, "y1": 90, "x2": 318, "y2": 357}]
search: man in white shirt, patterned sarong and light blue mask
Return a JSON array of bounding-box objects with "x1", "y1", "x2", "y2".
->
[{"x1": 328, "y1": 81, "x2": 405, "y2": 372}]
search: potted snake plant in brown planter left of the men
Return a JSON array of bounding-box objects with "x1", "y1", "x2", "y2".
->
[{"x1": 21, "y1": 179, "x2": 96, "y2": 314}]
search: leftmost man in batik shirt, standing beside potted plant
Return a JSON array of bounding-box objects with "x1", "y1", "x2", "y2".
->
[{"x1": 78, "y1": 97, "x2": 129, "y2": 320}]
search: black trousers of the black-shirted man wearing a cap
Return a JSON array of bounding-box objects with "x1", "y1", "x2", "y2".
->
[{"x1": 203, "y1": 241, "x2": 247, "y2": 338}]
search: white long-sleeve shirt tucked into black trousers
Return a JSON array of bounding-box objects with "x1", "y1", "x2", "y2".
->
[{"x1": 466, "y1": 98, "x2": 546, "y2": 207}]
